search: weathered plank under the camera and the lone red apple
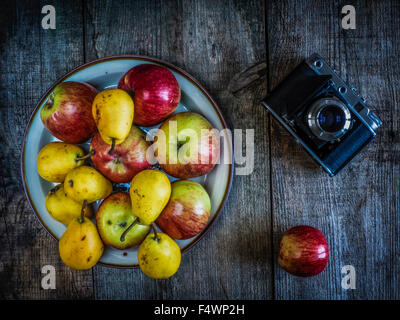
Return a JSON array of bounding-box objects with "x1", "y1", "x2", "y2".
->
[{"x1": 267, "y1": 1, "x2": 400, "y2": 299}]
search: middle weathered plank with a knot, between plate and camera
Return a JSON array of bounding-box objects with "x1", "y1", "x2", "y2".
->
[{"x1": 85, "y1": 1, "x2": 272, "y2": 299}]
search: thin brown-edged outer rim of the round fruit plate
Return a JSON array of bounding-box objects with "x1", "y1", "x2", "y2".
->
[{"x1": 20, "y1": 54, "x2": 234, "y2": 269}]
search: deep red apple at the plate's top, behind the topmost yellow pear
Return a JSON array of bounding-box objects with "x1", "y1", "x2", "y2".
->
[{"x1": 118, "y1": 64, "x2": 181, "y2": 127}]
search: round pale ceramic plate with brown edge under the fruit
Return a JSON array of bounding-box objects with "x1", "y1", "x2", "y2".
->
[{"x1": 21, "y1": 56, "x2": 233, "y2": 268}]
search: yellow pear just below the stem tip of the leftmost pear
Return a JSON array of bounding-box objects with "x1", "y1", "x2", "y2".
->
[{"x1": 64, "y1": 166, "x2": 112, "y2": 206}]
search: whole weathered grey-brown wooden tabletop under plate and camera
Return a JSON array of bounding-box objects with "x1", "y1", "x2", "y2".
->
[{"x1": 0, "y1": 0, "x2": 400, "y2": 299}]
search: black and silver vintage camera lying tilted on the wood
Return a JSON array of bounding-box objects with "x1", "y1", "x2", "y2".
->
[{"x1": 261, "y1": 54, "x2": 382, "y2": 176}]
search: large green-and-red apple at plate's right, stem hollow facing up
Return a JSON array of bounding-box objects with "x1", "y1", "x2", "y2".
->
[{"x1": 156, "y1": 112, "x2": 219, "y2": 179}]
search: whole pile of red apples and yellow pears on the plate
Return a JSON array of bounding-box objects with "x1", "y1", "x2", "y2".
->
[{"x1": 37, "y1": 64, "x2": 219, "y2": 278}]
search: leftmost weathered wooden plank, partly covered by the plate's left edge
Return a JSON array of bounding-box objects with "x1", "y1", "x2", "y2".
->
[{"x1": 0, "y1": 1, "x2": 93, "y2": 299}]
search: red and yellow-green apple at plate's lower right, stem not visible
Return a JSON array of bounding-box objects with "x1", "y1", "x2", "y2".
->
[{"x1": 156, "y1": 180, "x2": 211, "y2": 239}]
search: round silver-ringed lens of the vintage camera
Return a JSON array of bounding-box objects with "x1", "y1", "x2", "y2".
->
[{"x1": 307, "y1": 98, "x2": 351, "y2": 141}]
